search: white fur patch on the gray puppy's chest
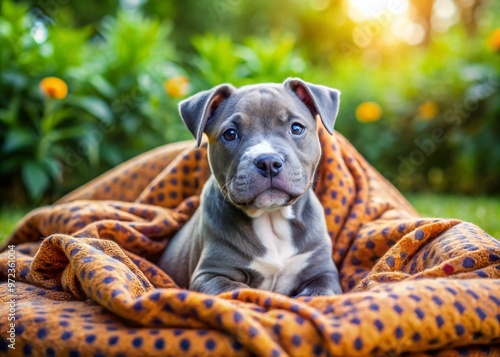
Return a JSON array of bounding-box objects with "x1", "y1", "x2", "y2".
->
[{"x1": 250, "y1": 206, "x2": 312, "y2": 295}]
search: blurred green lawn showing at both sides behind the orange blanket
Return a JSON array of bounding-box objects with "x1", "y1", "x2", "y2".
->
[{"x1": 0, "y1": 194, "x2": 500, "y2": 243}]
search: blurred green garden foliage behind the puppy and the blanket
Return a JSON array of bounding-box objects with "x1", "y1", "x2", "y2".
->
[{"x1": 0, "y1": 0, "x2": 500, "y2": 203}]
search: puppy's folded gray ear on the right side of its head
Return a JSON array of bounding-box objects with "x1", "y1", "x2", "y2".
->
[{"x1": 283, "y1": 78, "x2": 340, "y2": 134}]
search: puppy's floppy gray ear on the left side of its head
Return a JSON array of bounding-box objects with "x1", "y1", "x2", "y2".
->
[{"x1": 179, "y1": 84, "x2": 236, "y2": 147}]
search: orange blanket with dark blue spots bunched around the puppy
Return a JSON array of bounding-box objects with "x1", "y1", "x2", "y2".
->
[{"x1": 0, "y1": 129, "x2": 500, "y2": 356}]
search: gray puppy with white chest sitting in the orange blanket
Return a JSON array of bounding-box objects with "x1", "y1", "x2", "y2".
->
[{"x1": 159, "y1": 78, "x2": 342, "y2": 296}]
